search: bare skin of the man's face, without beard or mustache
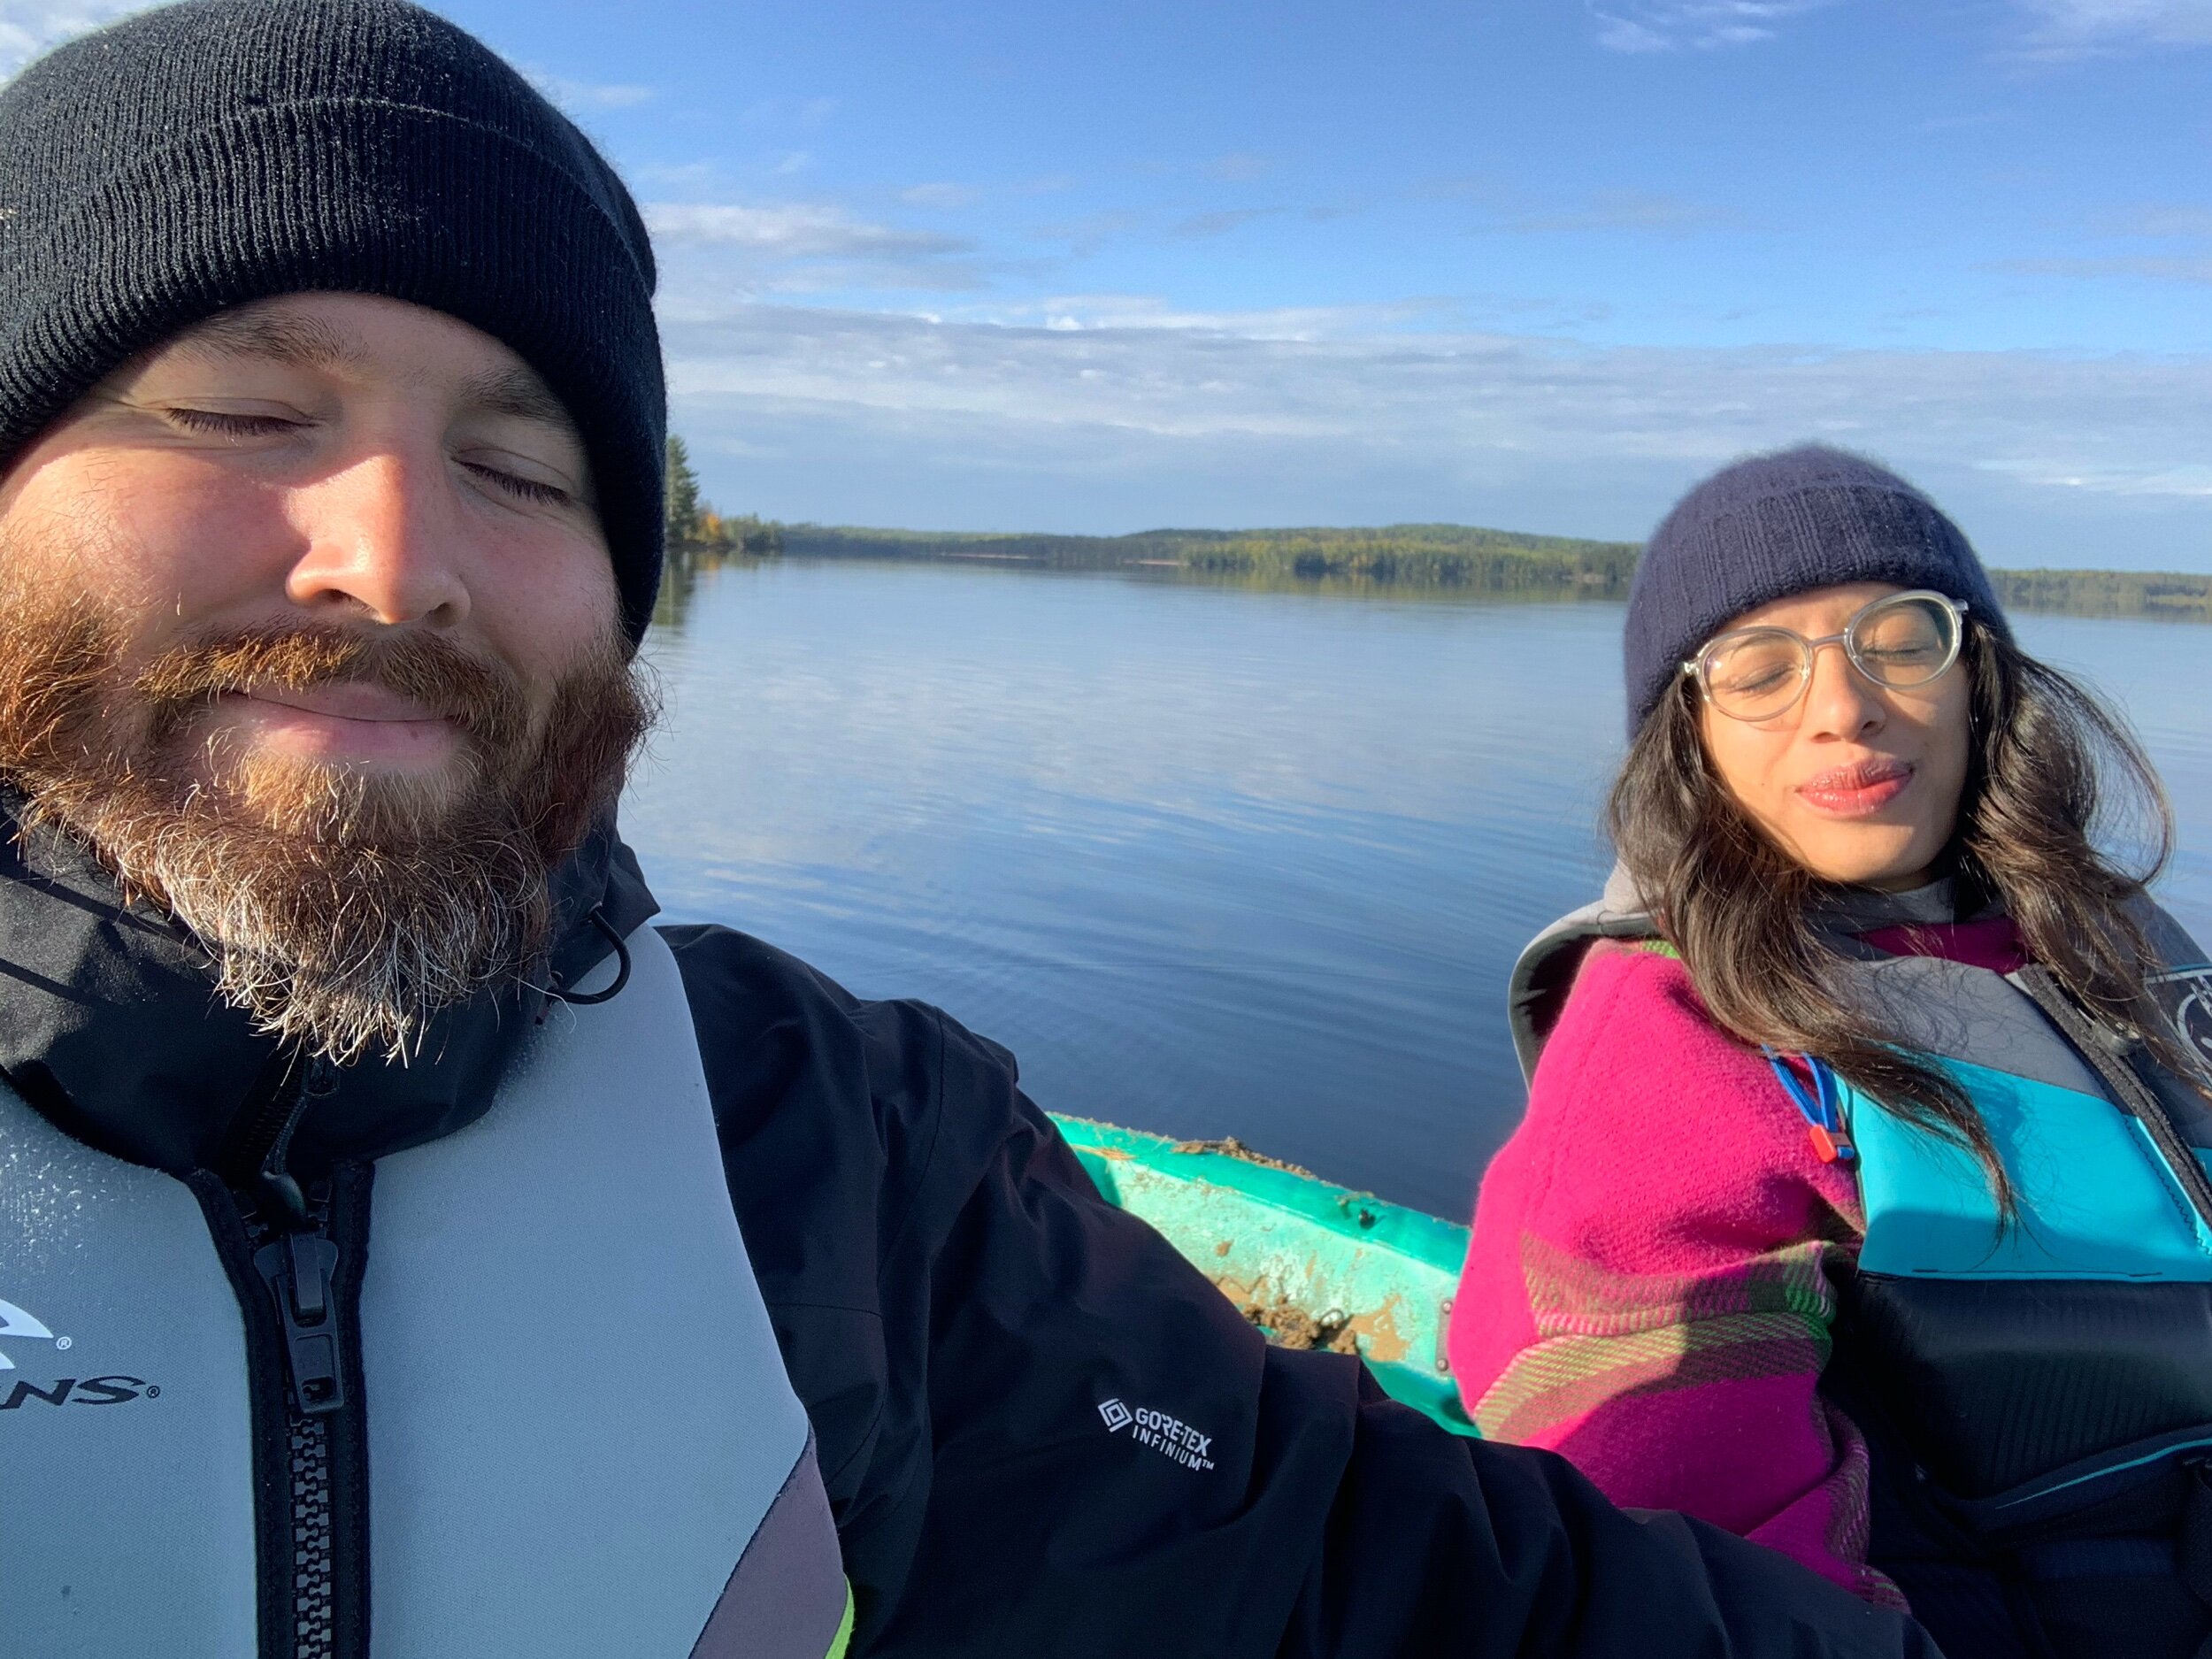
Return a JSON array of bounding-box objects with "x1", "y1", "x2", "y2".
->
[{"x1": 0, "y1": 295, "x2": 615, "y2": 827}]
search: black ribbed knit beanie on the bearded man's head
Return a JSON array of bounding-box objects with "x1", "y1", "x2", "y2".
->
[{"x1": 0, "y1": 0, "x2": 668, "y2": 641}]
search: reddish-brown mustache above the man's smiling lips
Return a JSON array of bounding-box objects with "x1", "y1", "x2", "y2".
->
[{"x1": 133, "y1": 624, "x2": 529, "y2": 755}]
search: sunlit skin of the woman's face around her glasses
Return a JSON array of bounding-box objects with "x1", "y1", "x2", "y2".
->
[{"x1": 1699, "y1": 582, "x2": 1971, "y2": 892}]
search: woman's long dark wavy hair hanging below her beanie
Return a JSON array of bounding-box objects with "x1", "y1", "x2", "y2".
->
[{"x1": 1606, "y1": 615, "x2": 2212, "y2": 1219}]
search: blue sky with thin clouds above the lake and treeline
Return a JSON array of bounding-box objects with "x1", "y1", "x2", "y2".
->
[{"x1": 12, "y1": 0, "x2": 2212, "y2": 571}]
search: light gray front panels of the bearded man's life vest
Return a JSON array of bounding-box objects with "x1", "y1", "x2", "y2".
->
[{"x1": 0, "y1": 927, "x2": 852, "y2": 1659}]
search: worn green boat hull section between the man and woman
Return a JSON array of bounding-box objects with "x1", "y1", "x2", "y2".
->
[{"x1": 1053, "y1": 1115, "x2": 1478, "y2": 1436}]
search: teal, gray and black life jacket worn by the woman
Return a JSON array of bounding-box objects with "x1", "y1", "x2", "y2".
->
[{"x1": 1513, "y1": 879, "x2": 2212, "y2": 1659}]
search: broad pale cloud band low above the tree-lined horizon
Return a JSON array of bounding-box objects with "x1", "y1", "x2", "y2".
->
[{"x1": 668, "y1": 301, "x2": 2212, "y2": 513}]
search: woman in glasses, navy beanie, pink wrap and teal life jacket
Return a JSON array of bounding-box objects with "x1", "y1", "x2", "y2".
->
[{"x1": 1451, "y1": 449, "x2": 2212, "y2": 1659}]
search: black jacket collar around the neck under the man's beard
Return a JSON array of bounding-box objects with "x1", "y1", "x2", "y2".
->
[{"x1": 0, "y1": 796, "x2": 659, "y2": 1175}]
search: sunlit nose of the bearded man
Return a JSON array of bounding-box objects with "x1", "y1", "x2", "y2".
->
[{"x1": 286, "y1": 447, "x2": 469, "y2": 628}]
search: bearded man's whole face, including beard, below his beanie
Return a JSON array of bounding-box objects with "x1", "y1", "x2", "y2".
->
[{"x1": 0, "y1": 295, "x2": 650, "y2": 1062}]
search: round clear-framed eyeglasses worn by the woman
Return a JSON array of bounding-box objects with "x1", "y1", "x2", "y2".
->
[{"x1": 1681, "y1": 588, "x2": 1967, "y2": 721}]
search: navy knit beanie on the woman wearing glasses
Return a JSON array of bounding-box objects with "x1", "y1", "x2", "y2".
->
[{"x1": 1622, "y1": 445, "x2": 2011, "y2": 737}]
